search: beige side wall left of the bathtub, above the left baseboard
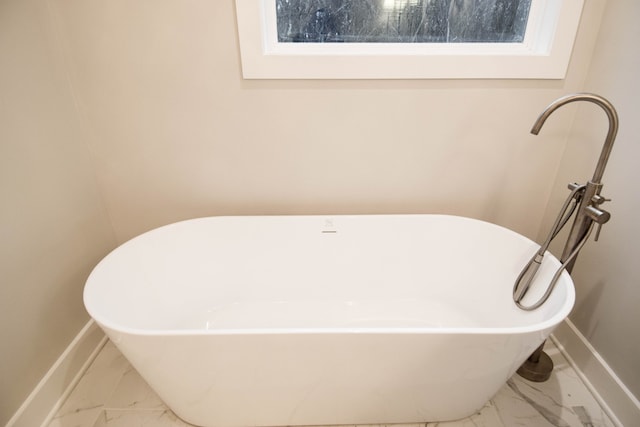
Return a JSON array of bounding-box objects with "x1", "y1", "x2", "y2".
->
[{"x1": 0, "y1": 0, "x2": 115, "y2": 425}]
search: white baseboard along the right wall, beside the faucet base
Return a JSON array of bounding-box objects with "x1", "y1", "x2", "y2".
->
[{"x1": 551, "y1": 319, "x2": 640, "y2": 427}]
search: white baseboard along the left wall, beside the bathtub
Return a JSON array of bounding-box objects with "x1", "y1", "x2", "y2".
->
[{"x1": 5, "y1": 320, "x2": 107, "y2": 427}]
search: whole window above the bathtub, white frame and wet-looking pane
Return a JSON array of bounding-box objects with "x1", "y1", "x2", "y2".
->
[{"x1": 236, "y1": 0, "x2": 583, "y2": 79}]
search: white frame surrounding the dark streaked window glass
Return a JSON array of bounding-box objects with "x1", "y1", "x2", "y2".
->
[{"x1": 236, "y1": 0, "x2": 584, "y2": 79}]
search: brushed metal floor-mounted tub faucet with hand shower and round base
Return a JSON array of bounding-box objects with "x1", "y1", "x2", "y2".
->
[{"x1": 513, "y1": 93, "x2": 618, "y2": 381}]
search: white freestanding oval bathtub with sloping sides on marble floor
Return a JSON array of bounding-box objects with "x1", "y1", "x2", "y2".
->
[{"x1": 84, "y1": 215, "x2": 574, "y2": 426}]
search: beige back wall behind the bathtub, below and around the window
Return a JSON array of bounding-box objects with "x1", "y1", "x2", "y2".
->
[{"x1": 46, "y1": 0, "x2": 601, "y2": 241}]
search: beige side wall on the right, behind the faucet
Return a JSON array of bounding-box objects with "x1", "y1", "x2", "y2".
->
[{"x1": 541, "y1": 0, "x2": 640, "y2": 398}]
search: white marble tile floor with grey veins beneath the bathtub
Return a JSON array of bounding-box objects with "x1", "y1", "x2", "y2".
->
[{"x1": 48, "y1": 341, "x2": 614, "y2": 427}]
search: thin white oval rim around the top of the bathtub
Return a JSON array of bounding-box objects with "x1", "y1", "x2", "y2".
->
[{"x1": 83, "y1": 213, "x2": 576, "y2": 337}]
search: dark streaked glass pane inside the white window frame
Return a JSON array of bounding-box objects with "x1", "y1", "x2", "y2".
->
[{"x1": 276, "y1": 0, "x2": 531, "y2": 43}]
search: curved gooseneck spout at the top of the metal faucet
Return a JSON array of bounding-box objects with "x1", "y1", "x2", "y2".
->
[{"x1": 531, "y1": 93, "x2": 618, "y2": 184}]
